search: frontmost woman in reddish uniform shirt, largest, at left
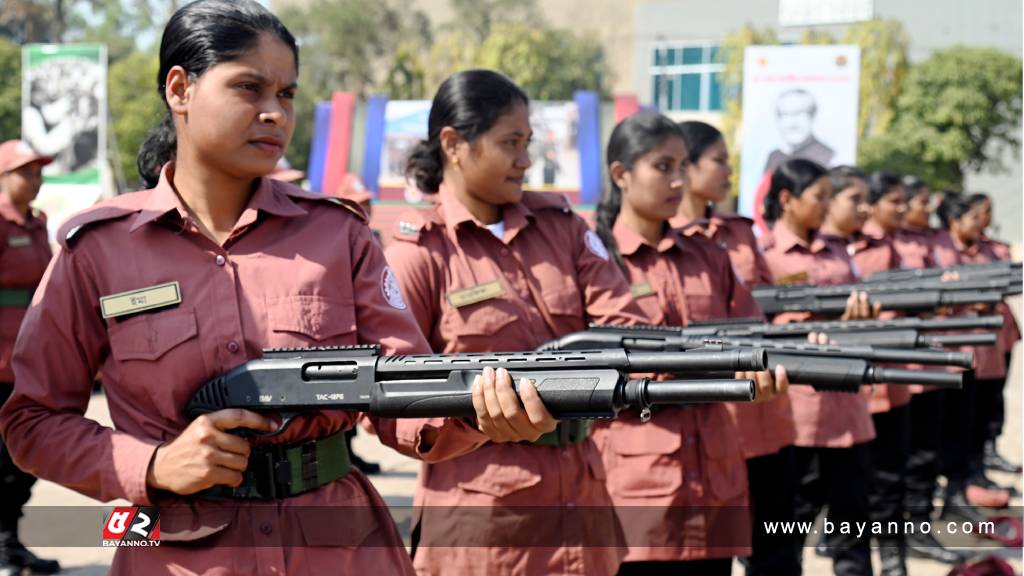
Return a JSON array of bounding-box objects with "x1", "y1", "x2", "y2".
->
[{"x1": 0, "y1": 0, "x2": 554, "y2": 575}]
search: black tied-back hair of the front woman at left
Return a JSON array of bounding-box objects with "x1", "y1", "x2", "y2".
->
[{"x1": 137, "y1": 0, "x2": 299, "y2": 188}]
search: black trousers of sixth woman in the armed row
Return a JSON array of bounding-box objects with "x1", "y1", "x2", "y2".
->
[{"x1": 868, "y1": 405, "x2": 910, "y2": 544}]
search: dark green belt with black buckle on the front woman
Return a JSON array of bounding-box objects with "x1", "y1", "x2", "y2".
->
[{"x1": 199, "y1": 431, "x2": 352, "y2": 500}]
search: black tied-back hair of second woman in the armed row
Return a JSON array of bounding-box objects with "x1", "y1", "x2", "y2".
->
[{"x1": 406, "y1": 70, "x2": 529, "y2": 194}]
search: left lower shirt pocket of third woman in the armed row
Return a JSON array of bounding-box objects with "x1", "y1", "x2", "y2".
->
[{"x1": 605, "y1": 411, "x2": 683, "y2": 498}]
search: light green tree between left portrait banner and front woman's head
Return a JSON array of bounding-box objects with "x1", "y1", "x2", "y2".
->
[{"x1": 108, "y1": 52, "x2": 161, "y2": 190}]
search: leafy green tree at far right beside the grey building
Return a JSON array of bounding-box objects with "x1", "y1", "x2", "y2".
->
[{"x1": 860, "y1": 46, "x2": 1022, "y2": 190}]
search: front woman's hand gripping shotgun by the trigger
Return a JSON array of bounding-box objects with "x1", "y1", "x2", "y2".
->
[{"x1": 145, "y1": 409, "x2": 278, "y2": 495}]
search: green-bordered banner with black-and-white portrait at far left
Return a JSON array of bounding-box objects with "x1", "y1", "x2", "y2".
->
[{"x1": 22, "y1": 44, "x2": 108, "y2": 236}]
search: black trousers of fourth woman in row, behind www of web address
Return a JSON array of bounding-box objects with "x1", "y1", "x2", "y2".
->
[{"x1": 739, "y1": 446, "x2": 800, "y2": 576}]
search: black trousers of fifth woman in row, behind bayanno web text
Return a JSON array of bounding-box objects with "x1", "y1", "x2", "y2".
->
[{"x1": 794, "y1": 443, "x2": 871, "y2": 576}]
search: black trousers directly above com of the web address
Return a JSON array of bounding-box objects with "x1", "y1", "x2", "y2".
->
[{"x1": 940, "y1": 371, "x2": 979, "y2": 487}]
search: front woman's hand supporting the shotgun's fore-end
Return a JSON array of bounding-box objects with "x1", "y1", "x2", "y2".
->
[{"x1": 473, "y1": 367, "x2": 558, "y2": 442}]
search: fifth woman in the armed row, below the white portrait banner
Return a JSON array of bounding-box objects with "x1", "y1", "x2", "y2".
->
[{"x1": 764, "y1": 159, "x2": 879, "y2": 576}]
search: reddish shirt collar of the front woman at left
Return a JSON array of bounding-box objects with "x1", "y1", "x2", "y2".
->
[{"x1": 131, "y1": 162, "x2": 306, "y2": 232}]
